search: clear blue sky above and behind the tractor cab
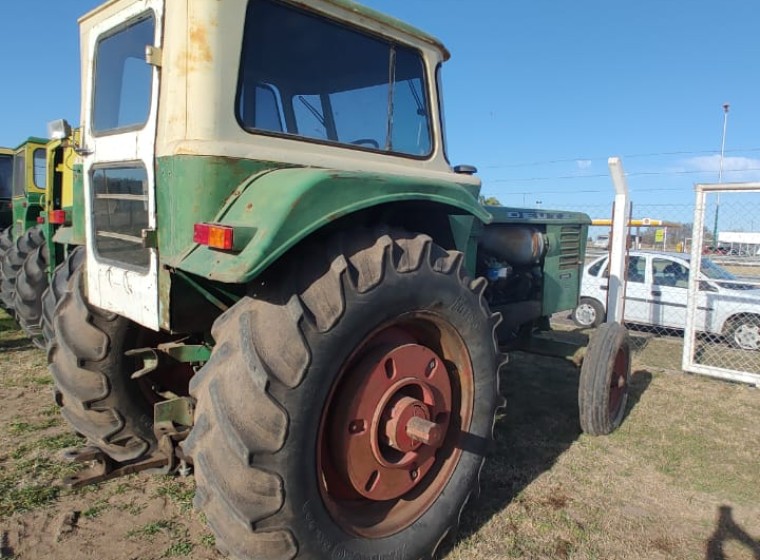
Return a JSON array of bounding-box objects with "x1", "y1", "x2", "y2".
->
[{"x1": 0, "y1": 0, "x2": 760, "y2": 221}]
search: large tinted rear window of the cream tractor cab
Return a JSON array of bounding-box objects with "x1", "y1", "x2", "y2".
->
[{"x1": 236, "y1": 0, "x2": 432, "y2": 157}]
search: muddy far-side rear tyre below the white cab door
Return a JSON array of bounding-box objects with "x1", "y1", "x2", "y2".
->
[{"x1": 48, "y1": 267, "x2": 156, "y2": 461}]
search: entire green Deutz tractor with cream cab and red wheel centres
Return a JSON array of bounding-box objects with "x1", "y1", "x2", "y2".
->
[{"x1": 48, "y1": 0, "x2": 630, "y2": 559}]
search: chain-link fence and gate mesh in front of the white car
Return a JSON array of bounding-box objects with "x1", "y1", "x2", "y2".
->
[{"x1": 552, "y1": 195, "x2": 760, "y2": 383}]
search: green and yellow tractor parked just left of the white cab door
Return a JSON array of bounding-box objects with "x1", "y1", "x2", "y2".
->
[{"x1": 2, "y1": 132, "x2": 84, "y2": 348}]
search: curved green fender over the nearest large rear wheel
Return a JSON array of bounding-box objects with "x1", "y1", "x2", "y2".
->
[{"x1": 176, "y1": 168, "x2": 491, "y2": 284}]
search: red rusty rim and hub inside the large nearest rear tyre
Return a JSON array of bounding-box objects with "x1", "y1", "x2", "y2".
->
[{"x1": 317, "y1": 313, "x2": 474, "y2": 538}]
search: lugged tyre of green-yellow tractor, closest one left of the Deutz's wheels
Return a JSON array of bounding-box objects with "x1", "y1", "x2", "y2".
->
[{"x1": 13, "y1": 243, "x2": 50, "y2": 348}]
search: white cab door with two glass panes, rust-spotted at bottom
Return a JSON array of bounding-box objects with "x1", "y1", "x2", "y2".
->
[{"x1": 83, "y1": 0, "x2": 163, "y2": 330}]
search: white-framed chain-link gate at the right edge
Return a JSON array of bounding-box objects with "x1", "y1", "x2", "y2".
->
[{"x1": 683, "y1": 183, "x2": 760, "y2": 386}]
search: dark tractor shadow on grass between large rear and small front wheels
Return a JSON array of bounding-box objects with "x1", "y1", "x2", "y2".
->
[{"x1": 450, "y1": 352, "x2": 652, "y2": 546}]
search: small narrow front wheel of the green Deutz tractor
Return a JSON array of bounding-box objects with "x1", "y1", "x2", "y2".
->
[{"x1": 578, "y1": 323, "x2": 631, "y2": 436}]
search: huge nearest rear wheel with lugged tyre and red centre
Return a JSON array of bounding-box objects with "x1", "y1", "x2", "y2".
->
[{"x1": 184, "y1": 231, "x2": 500, "y2": 559}]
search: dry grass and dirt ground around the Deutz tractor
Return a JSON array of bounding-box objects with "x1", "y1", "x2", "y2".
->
[{"x1": 0, "y1": 310, "x2": 760, "y2": 560}]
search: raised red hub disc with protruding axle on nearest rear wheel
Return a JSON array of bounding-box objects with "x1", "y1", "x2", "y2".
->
[{"x1": 328, "y1": 344, "x2": 452, "y2": 501}]
